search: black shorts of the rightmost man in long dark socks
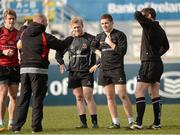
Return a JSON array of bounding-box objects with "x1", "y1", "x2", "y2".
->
[{"x1": 137, "y1": 60, "x2": 163, "y2": 83}]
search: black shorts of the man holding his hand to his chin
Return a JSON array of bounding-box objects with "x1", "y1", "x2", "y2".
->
[{"x1": 98, "y1": 68, "x2": 126, "y2": 86}]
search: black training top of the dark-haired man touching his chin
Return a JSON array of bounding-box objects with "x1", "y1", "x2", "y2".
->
[{"x1": 91, "y1": 29, "x2": 127, "y2": 70}]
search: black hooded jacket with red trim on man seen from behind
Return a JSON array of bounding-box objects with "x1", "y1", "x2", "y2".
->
[{"x1": 21, "y1": 22, "x2": 72, "y2": 69}]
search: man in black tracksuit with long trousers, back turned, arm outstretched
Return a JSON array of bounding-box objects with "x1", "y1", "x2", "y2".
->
[{"x1": 12, "y1": 14, "x2": 72, "y2": 133}]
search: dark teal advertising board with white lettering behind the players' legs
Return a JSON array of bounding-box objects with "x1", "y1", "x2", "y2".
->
[{"x1": 39, "y1": 63, "x2": 180, "y2": 105}]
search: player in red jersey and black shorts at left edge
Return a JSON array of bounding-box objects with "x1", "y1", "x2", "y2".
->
[{"x1": 0, "y1": 9, "x2": 20, "y2": 131}]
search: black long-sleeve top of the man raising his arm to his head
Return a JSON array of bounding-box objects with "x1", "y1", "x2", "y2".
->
[{"x1": 134, "y1": 11, "x2": 169, "y2": 61}]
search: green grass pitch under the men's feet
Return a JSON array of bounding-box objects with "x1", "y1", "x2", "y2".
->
[{"x1": 0, "y1": 104, "x2": 180, "y2": 134}]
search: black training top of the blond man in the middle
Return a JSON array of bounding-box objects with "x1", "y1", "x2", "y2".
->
[{"x1": 56, "y1": 32, "x2": 96, "y2": 71}]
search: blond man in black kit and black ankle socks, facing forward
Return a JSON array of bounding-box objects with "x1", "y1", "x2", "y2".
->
[{"x1": 56, "y1": 17, "x2": 98, "y2": 128}]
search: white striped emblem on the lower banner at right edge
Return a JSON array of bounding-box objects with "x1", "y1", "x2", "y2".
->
[{"x1": 159, "y1": 71, "x2": 180, "y2": 98}]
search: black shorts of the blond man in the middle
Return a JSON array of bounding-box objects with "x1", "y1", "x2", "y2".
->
[{"x1": 68, "y1": 71, "x2": 94, "y2": 89}]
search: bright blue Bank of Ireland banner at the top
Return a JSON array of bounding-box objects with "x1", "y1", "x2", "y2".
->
[{"x1": 67, "y1": 0, "x2": 180, "y2": 21}]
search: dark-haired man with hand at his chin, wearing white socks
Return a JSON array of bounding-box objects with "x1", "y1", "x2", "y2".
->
[{"x1": 92, "y1": 14, "x2": 134, "y2": 129}]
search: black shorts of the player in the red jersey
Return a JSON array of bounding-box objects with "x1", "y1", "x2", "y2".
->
[{"x1": 0, "y1": 66, "x2": 20, "y2": 85}]
